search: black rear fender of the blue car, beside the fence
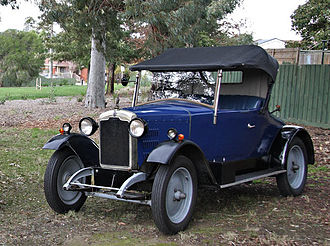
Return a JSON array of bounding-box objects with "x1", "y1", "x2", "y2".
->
[{"x1": 272, "y1": 125, "x2": 315, "y2": 168}]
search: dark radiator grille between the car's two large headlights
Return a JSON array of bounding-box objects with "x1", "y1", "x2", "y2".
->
[{"x1": 100, "y1": 118, "x2": 129, "y2": 167}]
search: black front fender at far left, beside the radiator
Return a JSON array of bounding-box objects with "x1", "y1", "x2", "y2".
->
[{"x1": 43, "y1": 133, "x2": 100, "y2": 167}]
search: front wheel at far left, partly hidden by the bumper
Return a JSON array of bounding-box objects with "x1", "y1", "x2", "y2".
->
[{"x1": 44, "y1": 148, "x2": 86, "y2": 214}]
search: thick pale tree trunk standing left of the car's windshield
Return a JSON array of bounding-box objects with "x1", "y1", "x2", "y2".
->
[{"x1": 85, "y1": 32, "x2": 105, "y2": 109}]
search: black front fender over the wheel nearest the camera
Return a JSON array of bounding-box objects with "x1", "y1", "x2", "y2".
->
[{"x1": 144, "y1": 140, "x2": 217, "y2": 184}]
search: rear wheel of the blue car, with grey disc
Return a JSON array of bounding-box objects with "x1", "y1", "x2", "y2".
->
[{"x1": 276, "y1": 137, "x2": 307, "y2": 196}]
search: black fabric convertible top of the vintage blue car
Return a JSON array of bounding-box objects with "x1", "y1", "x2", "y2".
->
[{"x1": 130, "y1": 45, "x2": 278, "y2": 81}]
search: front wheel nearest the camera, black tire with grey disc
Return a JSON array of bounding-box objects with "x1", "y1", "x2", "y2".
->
[{"x1": 151, "y1": 155, "x2": 197, "y2": 234}]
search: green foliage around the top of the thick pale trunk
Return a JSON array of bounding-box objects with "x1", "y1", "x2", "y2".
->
[{"x1": 39, "y1": 0, "x2": 136, "y2": 67}]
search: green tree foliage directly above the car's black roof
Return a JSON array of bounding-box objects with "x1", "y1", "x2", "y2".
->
[{"x1": 126, "y1": 0, "x2": 252, "y2": 56}]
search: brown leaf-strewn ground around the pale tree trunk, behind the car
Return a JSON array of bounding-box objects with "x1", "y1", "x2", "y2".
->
[{"x1": 0, "y1": 94, "x2": 130, "y2": 129}]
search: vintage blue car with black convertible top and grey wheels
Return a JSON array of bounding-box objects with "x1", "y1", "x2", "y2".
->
[{"x1": 44, "y1": 45, "x2": 314, "y2": 234}]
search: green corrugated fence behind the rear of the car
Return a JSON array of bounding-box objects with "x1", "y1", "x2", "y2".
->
[{"x1": 269, "y1": 65, "x2": 330, "y2": 128}]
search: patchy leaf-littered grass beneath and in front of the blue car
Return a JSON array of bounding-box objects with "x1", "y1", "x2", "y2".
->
[{"x1": 0, "y1": 128, "x2": 329, "y2": 245}]
